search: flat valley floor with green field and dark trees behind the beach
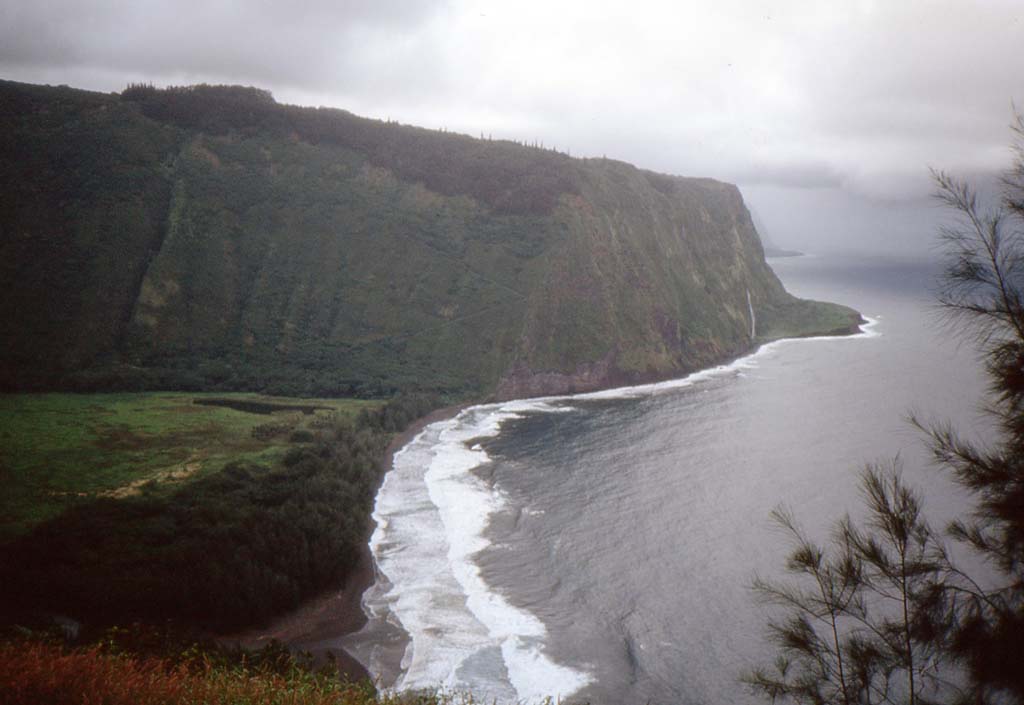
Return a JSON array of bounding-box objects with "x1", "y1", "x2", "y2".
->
[{"x1": 0, "y1": 395, "x2": 440, "y2": 633}]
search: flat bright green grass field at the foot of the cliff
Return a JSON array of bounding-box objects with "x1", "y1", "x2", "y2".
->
[{"x1": 0, "y1": 392, "x2": 380, "y2": 542}]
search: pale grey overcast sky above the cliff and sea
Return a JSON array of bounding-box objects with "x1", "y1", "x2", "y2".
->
[{"x1": 0, "y1": 0, "x2": 1024, "y2": 250}]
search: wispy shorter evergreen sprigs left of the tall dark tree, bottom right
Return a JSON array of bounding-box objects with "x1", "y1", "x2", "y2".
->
[{"x1": 743, "y1": 464, "x2": 954, "y2": 705}]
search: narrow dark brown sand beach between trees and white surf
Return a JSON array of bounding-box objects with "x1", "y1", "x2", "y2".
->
[{"x1": 221, "y1": 404, "x2": 471, "y2": 680}]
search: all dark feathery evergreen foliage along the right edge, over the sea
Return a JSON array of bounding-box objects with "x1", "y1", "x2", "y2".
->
[{"x1": 743, "y1": 116, "x2": 1024, "y2": 705}]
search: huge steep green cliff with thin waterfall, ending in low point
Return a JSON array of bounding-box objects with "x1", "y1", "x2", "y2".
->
[{"x1": 0, "y1": 82, "x2": 859, "y2": 397}]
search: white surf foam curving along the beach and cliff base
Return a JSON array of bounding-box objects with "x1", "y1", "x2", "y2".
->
[{"x1": 364, "y1": 318, "x2": 881, "y2": 702}]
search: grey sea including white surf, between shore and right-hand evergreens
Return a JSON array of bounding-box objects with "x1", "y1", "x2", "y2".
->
[{"x1": 344, "y1": 256, "x2": 985, "y2": 704}]
